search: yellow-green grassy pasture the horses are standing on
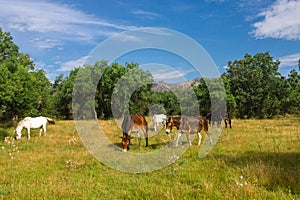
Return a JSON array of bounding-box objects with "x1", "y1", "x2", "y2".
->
[{"x1": 0, "y1": 117, "x2": 300, "y2": 199}]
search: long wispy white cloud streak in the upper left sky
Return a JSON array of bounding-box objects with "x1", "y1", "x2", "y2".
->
[{"x1": 0, "y1": 0, "x2": 135, "y2": 48}]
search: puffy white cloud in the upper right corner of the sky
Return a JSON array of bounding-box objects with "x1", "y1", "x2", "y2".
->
[{"x1": 252, "y1": 0, "x2": 300, "y2": 40}]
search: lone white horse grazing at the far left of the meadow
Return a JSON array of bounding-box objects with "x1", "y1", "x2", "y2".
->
[{"x1": 15, "y1": 116, "x2": 55, "y2": 140}]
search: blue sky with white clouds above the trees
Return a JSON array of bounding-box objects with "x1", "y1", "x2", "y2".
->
[{"x1": 0, "y1": 0, "x2": 300, "y2": 81}]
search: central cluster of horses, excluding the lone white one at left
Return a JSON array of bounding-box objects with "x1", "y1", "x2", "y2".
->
[{"x1": 121, "y1": 113, "x2": 231, "y2": 152}]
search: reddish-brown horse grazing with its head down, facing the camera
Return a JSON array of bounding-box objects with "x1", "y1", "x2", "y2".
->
[{"x1": 121, "y1": 114, "x2": 148, "y2": 152}]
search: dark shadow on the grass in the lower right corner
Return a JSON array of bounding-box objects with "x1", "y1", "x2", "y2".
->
[{"x1": 217, "y1": 151, "x2": 300, "y2": 195}]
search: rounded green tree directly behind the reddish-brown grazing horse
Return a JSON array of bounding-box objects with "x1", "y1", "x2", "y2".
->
[{"x1": 106, "y1": 63, "x2": 153, "y2": 117}]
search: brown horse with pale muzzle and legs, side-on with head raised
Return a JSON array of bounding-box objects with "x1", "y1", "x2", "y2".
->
[{"x1": 166, "y1": 115, "x2": 212, "y2": 146}]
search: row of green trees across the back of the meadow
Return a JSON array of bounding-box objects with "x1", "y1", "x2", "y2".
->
[{"x1": 0, "y1": 28, "x2": 300, "y2": 123}]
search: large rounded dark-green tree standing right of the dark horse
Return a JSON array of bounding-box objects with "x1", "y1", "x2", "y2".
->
[{"x1": 224, "y1": 52, "x2": 285, "y2": 118}]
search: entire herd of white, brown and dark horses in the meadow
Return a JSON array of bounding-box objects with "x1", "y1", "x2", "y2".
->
[{"x1": 15, "y1": 113, "x2": 231, "y2": 152}]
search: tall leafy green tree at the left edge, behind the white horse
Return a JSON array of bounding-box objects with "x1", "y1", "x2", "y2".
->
[{"x1": 0, "y1": 29, "x2": 50, "y2": 121}]
